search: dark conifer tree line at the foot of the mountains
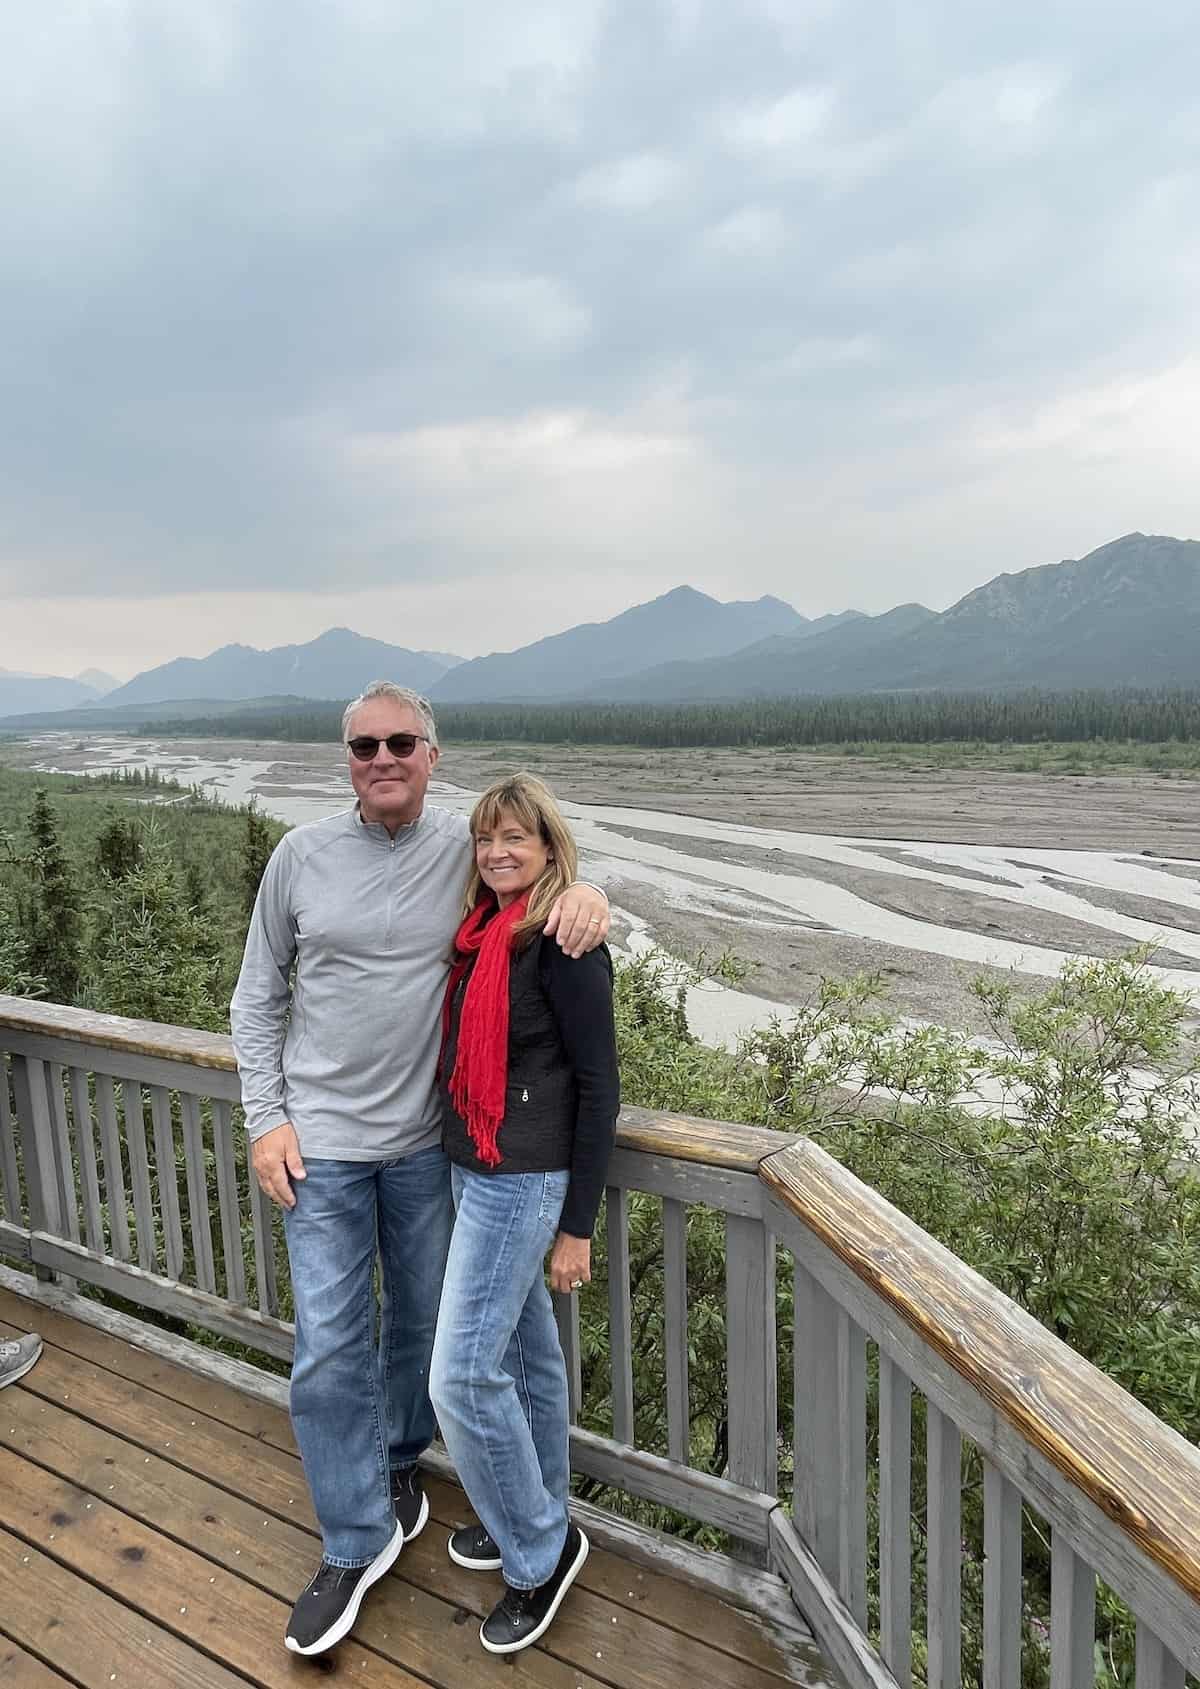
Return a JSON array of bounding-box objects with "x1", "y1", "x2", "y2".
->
[{"x1": 129, "y1": 689, "x2": 1200, "y2": 748}]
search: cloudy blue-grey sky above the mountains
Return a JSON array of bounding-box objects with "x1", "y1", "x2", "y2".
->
[{"x1": 0, "y1": 0, "x2": 1200, "y2": 677}]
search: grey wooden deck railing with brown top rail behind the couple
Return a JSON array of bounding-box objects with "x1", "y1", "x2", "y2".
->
[{"x1": 0, "y1": 997, "x2": 1200, "y2": 1689}]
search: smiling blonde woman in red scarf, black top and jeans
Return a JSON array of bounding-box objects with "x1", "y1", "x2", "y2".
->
[{"x1": 429, "y1": 774, "x2": 619, "y2": 1654}]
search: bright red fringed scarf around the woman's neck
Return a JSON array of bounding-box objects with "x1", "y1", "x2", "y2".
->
[{"x1": 445, "y1": 893, "x2": 529, "y2": 1167}]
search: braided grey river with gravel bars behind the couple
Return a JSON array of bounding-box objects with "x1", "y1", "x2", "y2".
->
[{"x1": 22, "y1": 735, "x2": 1200, "y2": 1042}]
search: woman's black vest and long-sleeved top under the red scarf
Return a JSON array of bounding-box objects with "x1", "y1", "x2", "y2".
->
[{"x1": 441, "y1": 934, "x2": 620, "y2": 1238}]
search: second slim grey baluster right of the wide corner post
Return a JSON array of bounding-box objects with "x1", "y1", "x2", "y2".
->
[{"x1": 879, "y1": 1350, "x2": 913, "y2": 1689}]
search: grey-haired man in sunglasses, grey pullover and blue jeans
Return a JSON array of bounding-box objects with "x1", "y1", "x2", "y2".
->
[{"x1": 230, "y1": 681, "x2": 608, "y2": 1654}]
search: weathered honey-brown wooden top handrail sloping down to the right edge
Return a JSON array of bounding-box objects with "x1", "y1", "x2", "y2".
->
[{"x1": 761, "y1": 1140, "x2": 1200, "y2": 1599}]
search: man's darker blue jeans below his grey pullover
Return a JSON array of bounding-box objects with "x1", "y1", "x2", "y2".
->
[{"x1": 284, "y1": 1145, "x2": 453, "y2": 1566}]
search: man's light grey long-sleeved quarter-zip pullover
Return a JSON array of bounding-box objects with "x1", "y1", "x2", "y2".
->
[{"x1": 230, "y1": 806, "x2": 472, "y2": 1160}]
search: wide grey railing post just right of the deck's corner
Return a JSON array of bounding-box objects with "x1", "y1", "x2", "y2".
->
[{"x1": 793, "y1": 1262, "x2": 842, "y2": 1584}]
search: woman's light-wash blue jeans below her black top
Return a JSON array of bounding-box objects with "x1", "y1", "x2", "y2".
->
[{"x1": 429, "y1": 1167, "x2": 571, "y2": 1589}]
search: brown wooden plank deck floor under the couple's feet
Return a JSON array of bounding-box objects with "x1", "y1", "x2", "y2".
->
[{"x1": 0, "y1": 1289, "x2": 832, "y2": 1689}]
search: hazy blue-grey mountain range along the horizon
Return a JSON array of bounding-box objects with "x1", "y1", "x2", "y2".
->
[{"x1": 0, "y1": 534, "x2": 1200, "y2": 725}]
